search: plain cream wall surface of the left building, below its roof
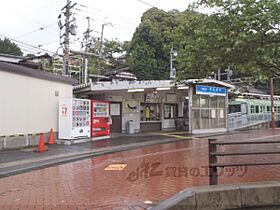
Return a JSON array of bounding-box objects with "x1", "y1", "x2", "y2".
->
[{"x1": 0, "y1": 71, "x2": 72, "y2": 136}]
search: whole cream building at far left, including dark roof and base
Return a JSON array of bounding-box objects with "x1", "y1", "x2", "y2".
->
[{"x1": 0, "y1": 62, "x2": 76, "y2": 149}]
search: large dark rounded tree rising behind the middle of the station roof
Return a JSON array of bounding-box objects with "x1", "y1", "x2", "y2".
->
[{"x1": 128, "y1": 8, "x2": 178, "y2": 80}]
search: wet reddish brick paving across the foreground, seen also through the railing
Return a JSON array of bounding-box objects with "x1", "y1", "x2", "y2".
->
[{"x1": 0, "y1": 130, "x2": 280, "y2": 210}]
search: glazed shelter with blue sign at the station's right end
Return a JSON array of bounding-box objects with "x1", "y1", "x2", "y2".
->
[{"x1": 184, "y1": 79, "x2": 235, "y2": 134}]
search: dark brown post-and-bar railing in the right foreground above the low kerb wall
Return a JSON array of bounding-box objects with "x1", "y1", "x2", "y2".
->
[{"x1": 208, "y1": 139, "x2": 280, "y2": 185}]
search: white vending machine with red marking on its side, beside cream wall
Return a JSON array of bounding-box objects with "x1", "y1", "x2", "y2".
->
[{"x1": 58, "y1": 98, "x2": 91, "y2": 139}]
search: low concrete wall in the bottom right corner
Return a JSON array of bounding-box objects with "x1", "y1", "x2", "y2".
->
[{"x1": 152, "y1": 181, "x2": 280, "y2": 210}]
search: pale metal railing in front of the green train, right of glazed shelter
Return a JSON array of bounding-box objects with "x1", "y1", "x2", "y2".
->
[{"x1": 228, "y1": 112, "x2": 280, "y2": 130}]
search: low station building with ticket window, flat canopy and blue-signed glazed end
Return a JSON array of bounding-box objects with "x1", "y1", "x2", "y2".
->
[{"x1": 74, "y1": 79, "x2": 234, "y2": 134}]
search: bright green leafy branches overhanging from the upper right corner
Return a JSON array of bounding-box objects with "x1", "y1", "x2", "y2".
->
[{"x1": 176, "y1": 0, "x2": 280, "y2": 80}]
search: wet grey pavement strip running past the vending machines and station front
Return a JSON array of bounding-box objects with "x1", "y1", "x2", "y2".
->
[{"x1": 0, "y1": 132, "x2": 196, "y2": 177}]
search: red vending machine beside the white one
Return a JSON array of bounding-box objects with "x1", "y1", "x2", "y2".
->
[{"x1": 91, "y1": 100, "x2": 110, "y2": 138}]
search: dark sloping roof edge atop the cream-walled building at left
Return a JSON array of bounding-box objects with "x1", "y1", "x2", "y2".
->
[{"x1": 0, "y1": 61, "x2": 77, "y2": 85}]
